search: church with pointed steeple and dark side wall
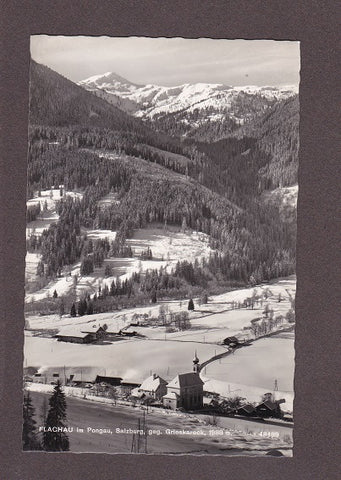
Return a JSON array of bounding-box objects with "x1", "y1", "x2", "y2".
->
[{"x1": 162, "y1": 353, "x2": 204, "y2": 410}]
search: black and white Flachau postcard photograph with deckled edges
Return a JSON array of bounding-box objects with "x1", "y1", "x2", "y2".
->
[{"x1": 22, "y1": 35, "x2": 300, "y2": 457}]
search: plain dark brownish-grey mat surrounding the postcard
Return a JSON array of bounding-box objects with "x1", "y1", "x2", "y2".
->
[{"x1": 0, "y1": 0, "x2": 341, "y2": 480}]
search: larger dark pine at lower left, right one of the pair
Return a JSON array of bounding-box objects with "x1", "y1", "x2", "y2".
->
[{"x1": 43, "y1": 380, "x2": 70, "y2": 452}]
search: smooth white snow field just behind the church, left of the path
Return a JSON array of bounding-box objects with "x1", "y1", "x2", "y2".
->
[{"x1": 24, "y1": 335, "x2": 225, "y2": 382}]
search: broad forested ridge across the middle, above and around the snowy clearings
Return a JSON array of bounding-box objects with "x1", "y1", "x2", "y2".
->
[{"x1": 29, "y1": 147, "x2": 294, "y2": 288}]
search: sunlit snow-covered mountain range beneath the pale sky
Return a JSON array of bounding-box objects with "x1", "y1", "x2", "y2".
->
[{"x1": 79, "y1": 72, "x2": 298, "y2": 138}]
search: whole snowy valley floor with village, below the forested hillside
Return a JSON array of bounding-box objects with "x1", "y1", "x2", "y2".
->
[{"x1": 24, "y1": 277, "x2": 295, "y2": 455}]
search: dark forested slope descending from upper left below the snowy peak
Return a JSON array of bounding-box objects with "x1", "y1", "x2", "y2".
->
[{"x1": 29, "y1": 60, "x2": 191, "y2": 159}]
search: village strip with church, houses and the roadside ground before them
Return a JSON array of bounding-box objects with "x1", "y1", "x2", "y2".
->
[{"x1": 24, "y1": 345, "x2": 293, "y2": 422}]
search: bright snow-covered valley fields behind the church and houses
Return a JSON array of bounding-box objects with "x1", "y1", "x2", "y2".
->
[{"x1": 25, "y1": 276, "x2": 296, "y2": 411}]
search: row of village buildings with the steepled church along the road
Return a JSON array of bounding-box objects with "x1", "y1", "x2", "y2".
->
[{"x1": 25, "y1": 354, "x2": 286, "y2": 421}]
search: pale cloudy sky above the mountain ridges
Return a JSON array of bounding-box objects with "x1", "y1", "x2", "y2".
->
[{"x1": 31, "y1": 35, "x2": 300, "y2": 86}]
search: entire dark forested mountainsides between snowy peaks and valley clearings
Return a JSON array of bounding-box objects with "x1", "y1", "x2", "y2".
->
[{"x1": 27, "y1": 62, "x2": 298, "y2": 312}]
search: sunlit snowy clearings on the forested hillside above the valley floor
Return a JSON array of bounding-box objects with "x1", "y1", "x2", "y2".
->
[{"x1": 25, "y1": 226, "x2": 212, "y2": 303}]
